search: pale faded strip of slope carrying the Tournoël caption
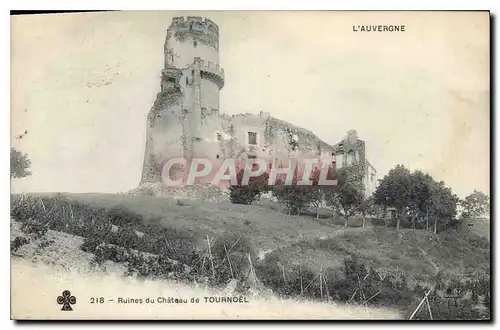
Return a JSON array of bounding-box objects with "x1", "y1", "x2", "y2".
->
[{"x1": 11, "y1": 223, "x2": 401, "y2": 320}]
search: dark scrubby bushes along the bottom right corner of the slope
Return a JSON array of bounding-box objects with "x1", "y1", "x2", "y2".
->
[{"x1": 256, "y1": 254, "x2": 490, "y2": 320}]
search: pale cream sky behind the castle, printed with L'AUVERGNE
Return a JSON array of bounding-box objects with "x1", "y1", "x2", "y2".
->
[{"x1": 11, "y1": 11, "x2": 490, "y2": 197}]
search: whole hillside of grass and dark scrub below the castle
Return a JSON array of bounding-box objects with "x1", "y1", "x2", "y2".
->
[{"x1": 11, "y1": 194, "x2": 490, "y2": 319}]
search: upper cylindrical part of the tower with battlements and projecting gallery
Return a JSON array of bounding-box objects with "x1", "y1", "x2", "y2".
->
[{"x1": 165, "y1": 16, "x2": 224, "y2": 113}]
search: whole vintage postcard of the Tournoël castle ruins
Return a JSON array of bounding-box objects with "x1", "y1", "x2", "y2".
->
[{"x1": 10, "y1": 11, "x2": 491, "y2": 320}]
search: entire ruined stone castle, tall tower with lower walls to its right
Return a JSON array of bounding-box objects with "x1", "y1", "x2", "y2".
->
[{"x1": 141, "y1": 16, "x2": 377, "y2": 196}]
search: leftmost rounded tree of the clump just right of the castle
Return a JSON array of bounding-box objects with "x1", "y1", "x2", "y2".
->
[{"x1": 373, "y1": 165, "x2": 412, "y2": 229}]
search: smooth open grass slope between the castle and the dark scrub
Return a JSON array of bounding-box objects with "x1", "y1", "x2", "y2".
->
[{"x1": 20, "y1": 194, "x2": 490, "y2": 281}]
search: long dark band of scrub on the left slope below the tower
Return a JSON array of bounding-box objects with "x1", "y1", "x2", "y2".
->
[{"x1": 11, "y1": 195, "x2": 201, "y2": 264}]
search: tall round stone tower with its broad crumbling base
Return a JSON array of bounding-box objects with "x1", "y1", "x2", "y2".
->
[{"x1": 141, "y1": 16, "x2": 224, "y2": 183}]
